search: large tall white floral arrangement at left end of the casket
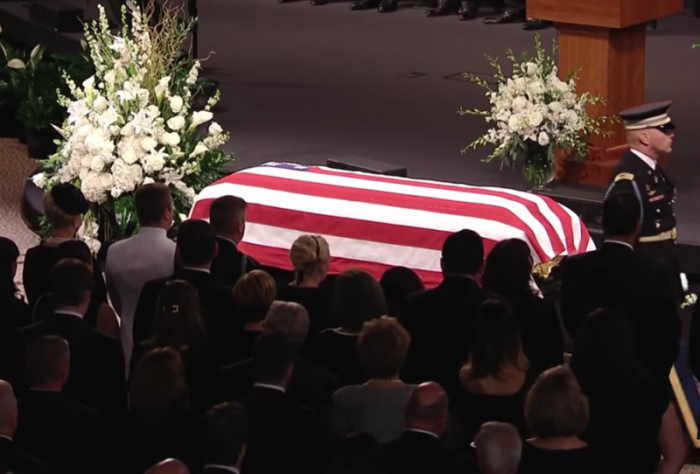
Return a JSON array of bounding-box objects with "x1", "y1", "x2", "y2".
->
[{"x1": 33, "y1": 2, "x2": 233, "y2": 250}]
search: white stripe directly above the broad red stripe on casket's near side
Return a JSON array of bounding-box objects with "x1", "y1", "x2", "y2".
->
[{"x1": 192, "y1": 183, "x2": 555, "y2": 262}]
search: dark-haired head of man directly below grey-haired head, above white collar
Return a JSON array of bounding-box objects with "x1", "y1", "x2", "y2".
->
[{"x1": 253, "y1": 331, "x2": 294, "y2": 385}]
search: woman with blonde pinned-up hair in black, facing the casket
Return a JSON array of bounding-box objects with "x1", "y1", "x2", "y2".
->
[{"x1": 277, "y1": 234, "x2": 333, "y2": 336}]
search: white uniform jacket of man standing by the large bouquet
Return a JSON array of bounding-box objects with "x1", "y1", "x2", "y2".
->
[{"x1": 105, "y1": 227, "x2": 175, "y2": 372}]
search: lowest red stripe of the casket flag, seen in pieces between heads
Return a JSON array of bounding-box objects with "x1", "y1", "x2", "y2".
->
[{"x1": 239, "y1": 242, "x2": 442, "y2": 288}]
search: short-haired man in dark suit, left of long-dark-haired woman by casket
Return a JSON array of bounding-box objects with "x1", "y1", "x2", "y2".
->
[{"x1": 399, "y1": 230, "x2": 485, "y2": 388}]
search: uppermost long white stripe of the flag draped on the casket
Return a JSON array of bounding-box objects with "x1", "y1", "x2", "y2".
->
[{"x1": 238, "y1": 167, "x2": 555, "y2": 258}]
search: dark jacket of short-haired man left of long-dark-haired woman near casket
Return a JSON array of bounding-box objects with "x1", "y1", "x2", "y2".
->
[{"x1": 399, "y1": 276, "x2": 485, "y2": 388}]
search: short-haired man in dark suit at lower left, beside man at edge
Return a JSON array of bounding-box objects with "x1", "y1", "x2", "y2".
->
[{"x1": 15, "y1": 336, "x2": 106, "y2": 474}]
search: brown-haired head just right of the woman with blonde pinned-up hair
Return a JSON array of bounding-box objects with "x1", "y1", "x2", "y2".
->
[{"x1": 331, "y1": 269, "x2": 387, "y2": 331}]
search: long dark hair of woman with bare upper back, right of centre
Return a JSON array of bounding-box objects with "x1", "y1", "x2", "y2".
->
[{"x1": 461, "y1": 298, "x2": 527, "y2": 379}]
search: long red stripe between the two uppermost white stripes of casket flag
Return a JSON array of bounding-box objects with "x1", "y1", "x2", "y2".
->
[{"x1": 217, "y1": 173, "x2": 552, "y2": 261}]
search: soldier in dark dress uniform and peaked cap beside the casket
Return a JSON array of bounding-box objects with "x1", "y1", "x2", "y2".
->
[{"x1": 608, "y1": 101, "x2": 686, "y2": 302}]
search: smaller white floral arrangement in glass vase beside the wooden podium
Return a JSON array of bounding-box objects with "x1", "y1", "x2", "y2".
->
[{"x1": 459, "y1": 35, "x2": 614, "y2": 186}]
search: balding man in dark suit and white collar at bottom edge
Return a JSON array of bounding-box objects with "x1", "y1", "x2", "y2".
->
[{"x1": 385, "y1": 382, "x2": 476, "y2": 474}]
